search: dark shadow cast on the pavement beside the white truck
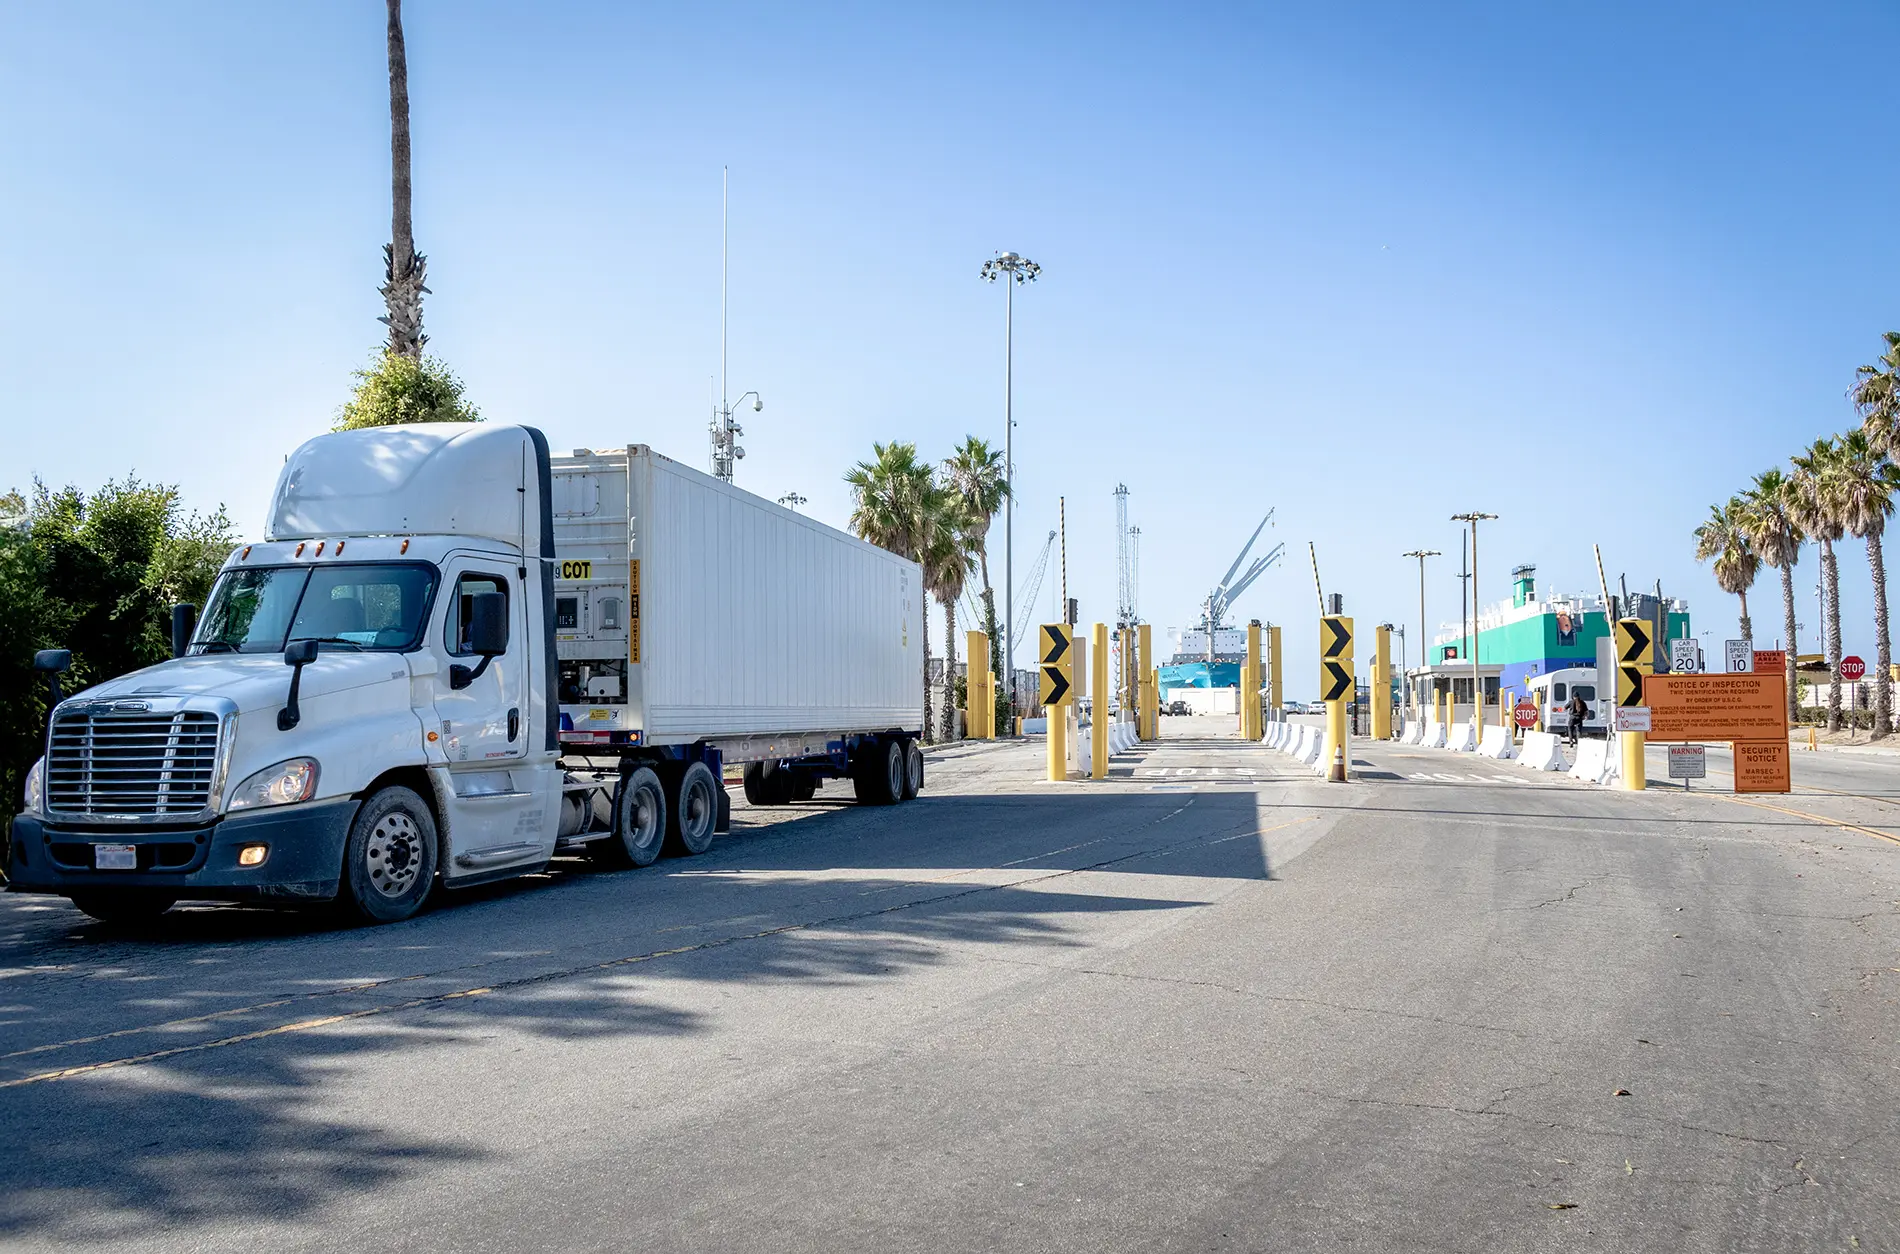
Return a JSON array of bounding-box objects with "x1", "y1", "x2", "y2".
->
[{"x1": 0, "y1": 792, "x2": 1269, "y2": 1243}]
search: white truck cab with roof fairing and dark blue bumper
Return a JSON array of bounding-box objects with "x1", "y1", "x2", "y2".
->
[{"x1": 8, "y1": 424, "x2": 564, "y2": 922}]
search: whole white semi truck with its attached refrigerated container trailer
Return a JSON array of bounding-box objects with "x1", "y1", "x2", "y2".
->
[{"x1": 8, "y1": 424, "x2": 923, "y2": 922}]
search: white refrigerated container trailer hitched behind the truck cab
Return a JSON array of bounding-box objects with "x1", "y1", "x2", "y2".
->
[{"x1": 553, "y1": 445, "x2": 923, "y2": 804}]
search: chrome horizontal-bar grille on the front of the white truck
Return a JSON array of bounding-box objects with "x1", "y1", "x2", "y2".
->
[{"x1": 46, "y1": 709, "x2": 219, "y2": 819}]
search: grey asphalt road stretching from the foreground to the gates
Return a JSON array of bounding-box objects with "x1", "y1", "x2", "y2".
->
[{"x1": 0, "y1": 720, "x2": 1900, "y2": 1252}]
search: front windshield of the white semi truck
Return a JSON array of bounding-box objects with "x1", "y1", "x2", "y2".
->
[{"x1": 192, "y1": 562, "x2": 435, "y2": 654}]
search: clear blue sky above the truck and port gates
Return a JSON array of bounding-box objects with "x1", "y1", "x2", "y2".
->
[{"x1": 0, "y1": 0, "x2": 1900, "y2": 695}]
